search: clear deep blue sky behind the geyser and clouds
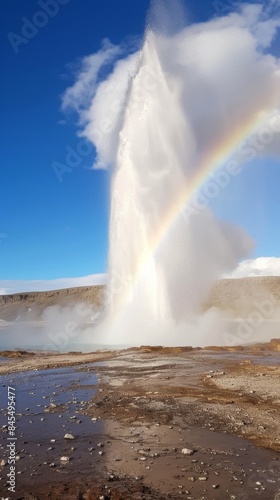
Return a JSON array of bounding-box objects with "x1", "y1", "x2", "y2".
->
[{"x1": 0, "y1": 0, "x2": 280, "y2": 290}]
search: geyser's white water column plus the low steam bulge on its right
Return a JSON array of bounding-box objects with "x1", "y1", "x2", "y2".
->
[{"x1": 106, "y1": 21, "x2": 250, "y2": 343}]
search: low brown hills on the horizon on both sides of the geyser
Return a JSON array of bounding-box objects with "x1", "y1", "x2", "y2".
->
[{"x1": 0, "y1": 276, "x2": 280, "y2": 326}]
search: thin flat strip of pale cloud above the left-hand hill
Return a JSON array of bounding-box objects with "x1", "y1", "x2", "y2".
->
[{"x1": 0, "y1": 274, "x2": 107, "y2": 295}]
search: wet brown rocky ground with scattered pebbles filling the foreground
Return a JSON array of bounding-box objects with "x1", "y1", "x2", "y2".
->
[{"x1": 0, "y1": 341, "x2": 280, "y2": 500}]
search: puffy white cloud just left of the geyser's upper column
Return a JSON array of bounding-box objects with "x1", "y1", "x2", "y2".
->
[{"x1": 62, "y1": 38, "x2": 139, "y2": 169}]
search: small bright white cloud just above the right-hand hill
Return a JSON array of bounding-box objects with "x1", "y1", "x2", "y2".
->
[{"x1": 226, "y1": 257, "x2": 280, "y2": 278}]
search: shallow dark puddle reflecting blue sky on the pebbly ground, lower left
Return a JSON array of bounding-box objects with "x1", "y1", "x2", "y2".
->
[{"x1": 0, "y1": 367, "x2": 104, "y2": 484}]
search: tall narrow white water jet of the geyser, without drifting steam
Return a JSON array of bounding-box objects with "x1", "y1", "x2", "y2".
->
[{"x1": 106, "y1": 32, "x2": 193, "y2": 319}]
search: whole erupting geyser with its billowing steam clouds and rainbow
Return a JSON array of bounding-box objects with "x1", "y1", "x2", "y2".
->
[{"x1": 66, "y1": 0, "x2": 280, "y2": 345}]
